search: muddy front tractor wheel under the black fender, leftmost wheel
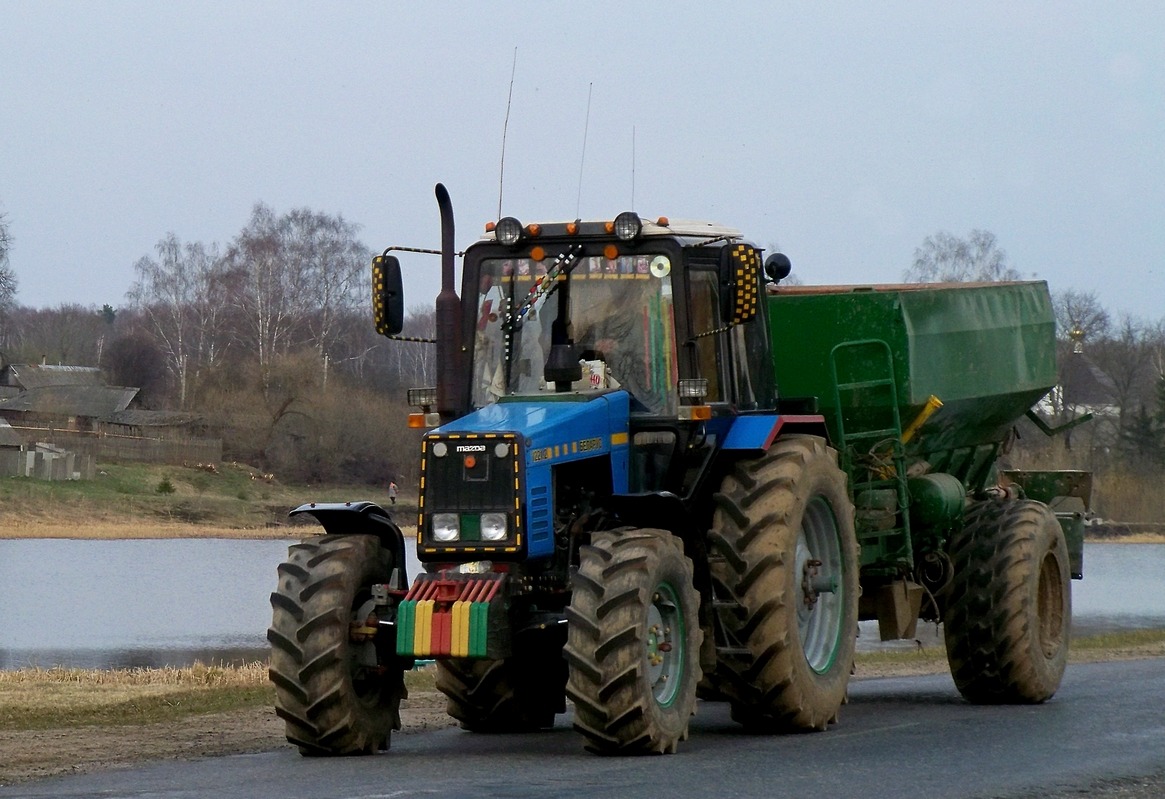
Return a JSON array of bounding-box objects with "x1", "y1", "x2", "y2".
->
[{"x1": 267, "y1": 535, "x2": 407, "y2": 755}]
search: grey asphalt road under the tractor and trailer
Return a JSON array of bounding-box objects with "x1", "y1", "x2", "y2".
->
[{"x1": 0, "y1": 658, "x2": 1165, "y2": 799}]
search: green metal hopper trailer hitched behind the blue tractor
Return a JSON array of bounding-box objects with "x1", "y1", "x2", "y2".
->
[{"x1": 768, "y1": 282, "x2": 1090, "y2": 695}]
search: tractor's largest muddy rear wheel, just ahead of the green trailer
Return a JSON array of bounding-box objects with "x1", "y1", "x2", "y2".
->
[{"x1": 709, "y1": 436, "x2": 859, "y2": 731}]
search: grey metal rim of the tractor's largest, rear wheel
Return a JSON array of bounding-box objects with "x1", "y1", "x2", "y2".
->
[{"x1": 795, "y1": 496, "x2": 845, "y2": 673}]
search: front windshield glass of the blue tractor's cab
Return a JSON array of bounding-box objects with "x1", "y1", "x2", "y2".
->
[{"x1": 473, "y1": 254, "x2": 678, "y2": 415}]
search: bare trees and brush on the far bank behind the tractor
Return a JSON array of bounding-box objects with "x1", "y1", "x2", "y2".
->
[{"x1": 0, "y1": 209, "x2": 1165, "y2": 491}]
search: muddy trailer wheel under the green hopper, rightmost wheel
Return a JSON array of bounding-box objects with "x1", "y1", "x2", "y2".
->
[{"x1": 944, "y1": 500, "x2": 1072, "y2": 705}]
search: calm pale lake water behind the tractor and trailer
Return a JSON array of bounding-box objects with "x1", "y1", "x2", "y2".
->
[{"x1": 0, "y1": 539, "x2": 1165, "y2": 669}]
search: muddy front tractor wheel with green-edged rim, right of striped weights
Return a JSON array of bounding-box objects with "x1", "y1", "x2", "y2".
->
[{"x1": 565, "y1": 530, "x2": 702, "y2": 755}]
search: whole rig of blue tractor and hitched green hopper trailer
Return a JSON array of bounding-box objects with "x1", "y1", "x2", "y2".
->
[{"x1": 268, "y1": 194, "x2": 1089, "y2": 755}]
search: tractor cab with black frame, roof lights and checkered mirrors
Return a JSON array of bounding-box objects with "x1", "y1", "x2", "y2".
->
[{"x1": 374, "y1": 212, "x2": 788, "y2": 507}]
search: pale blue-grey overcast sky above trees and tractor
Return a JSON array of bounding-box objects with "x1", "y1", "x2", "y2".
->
[{"x1": 0, "y1": 0, "x2": 1165, "y2": 321}]
